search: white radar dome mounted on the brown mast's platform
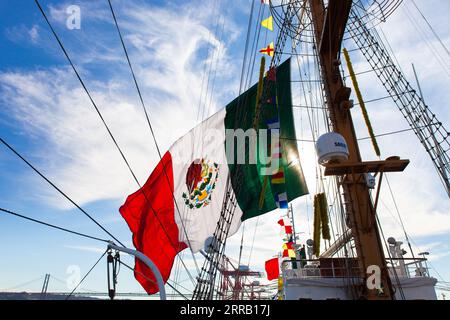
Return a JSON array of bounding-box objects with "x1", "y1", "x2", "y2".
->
[{"x1": 316, "y1": 132, "x2": 348, "y2": 165}]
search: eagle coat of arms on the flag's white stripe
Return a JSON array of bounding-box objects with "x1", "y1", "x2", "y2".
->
[{"x1": 183, "y1": 159, "x2": 219, "y2": 209}]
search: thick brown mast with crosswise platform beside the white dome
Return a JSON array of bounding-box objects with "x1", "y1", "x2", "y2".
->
[{"x1": 308, "y1": 0, "x2": 402, "y2": 300}]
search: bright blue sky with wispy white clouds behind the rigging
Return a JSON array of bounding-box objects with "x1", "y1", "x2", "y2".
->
[{"x1": 0, "y1": 0, "x2": 450, "y2": 300}]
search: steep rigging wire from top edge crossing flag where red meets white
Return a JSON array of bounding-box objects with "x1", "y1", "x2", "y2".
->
[{"x1": 108, "y1": 0, "x2": 199, "y2": 272}]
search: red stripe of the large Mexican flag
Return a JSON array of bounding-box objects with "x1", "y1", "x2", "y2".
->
[{"x1": 119, "y1": 152, "x2": 187, "y2": 294}]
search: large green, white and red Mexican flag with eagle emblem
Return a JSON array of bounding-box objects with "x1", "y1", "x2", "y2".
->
[{"x1": 120, "y1": 60, "x2": 308, "y2": 294}]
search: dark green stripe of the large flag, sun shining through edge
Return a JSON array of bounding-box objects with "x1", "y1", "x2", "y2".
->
[{"x1": 225, "y1": 60, "x2": 308, "y2": 221}]
